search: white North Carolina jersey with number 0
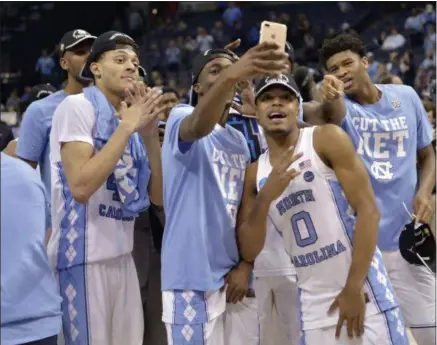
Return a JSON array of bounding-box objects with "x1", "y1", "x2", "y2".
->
[{"x1": 258, "y1": 127, "x2": 398, "y2": 330}]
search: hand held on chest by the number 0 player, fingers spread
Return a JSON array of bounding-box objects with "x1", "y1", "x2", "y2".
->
[{"x1": 262, "y1": 146, "x2": 302, "y2": 201}]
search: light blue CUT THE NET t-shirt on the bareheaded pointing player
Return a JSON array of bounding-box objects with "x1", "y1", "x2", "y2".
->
[{"x1": 342, "y1": 85, "x2": 433, "y2": 250}]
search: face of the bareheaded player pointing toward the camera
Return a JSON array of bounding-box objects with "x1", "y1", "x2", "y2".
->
[{"x1": 326, "y1": 50, "x2": 369, "y2": 95}]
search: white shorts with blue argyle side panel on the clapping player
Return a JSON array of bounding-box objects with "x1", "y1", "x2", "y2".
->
[{"x1": 58, "y1": 254, "x2": 144, "y2": 345}]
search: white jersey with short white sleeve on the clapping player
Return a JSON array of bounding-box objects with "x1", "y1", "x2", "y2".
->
[{"x1": 47, "y1": 94, "x2": 143, "y2": 269}]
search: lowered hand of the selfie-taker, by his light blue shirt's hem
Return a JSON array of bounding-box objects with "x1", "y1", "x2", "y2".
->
[{"x1": 225, "y1": 262, "x2": 252, "y2": 304}]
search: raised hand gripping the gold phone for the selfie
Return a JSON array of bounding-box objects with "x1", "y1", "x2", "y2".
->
[{"x1": 226, "y1": 42, "x2": 288, "y2": 81}]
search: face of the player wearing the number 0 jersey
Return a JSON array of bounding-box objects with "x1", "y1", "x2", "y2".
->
[{"x1": 256, "y1": 86, "x2": 299, "y2": 136}]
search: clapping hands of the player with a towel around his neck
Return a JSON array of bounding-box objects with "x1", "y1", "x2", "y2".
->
[{"x1": 115, "y1": 89, "x2": 163, "y2": 132}]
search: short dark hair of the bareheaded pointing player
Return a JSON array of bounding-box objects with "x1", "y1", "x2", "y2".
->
[{"x1": 319, "y1": 33, "x2": 367, "y2": 68}]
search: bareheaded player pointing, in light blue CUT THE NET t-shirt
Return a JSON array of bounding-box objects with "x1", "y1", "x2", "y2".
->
[{"x1": 307, "y1": 34, "x2": 436, "y2": 345}]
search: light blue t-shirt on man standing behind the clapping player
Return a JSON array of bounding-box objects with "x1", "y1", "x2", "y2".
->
[{"x1": 16, "y1": 90, "x2": 67, "y2": 227}]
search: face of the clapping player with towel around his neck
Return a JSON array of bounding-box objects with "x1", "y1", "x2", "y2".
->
[{"x1": 91, "y1": 46, "x2": 139, "y2": 98}]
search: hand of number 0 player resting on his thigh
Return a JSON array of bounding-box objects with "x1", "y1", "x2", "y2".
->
[{"x1": 328, "y1": 287, "x2": 366, "y2": 339}]
